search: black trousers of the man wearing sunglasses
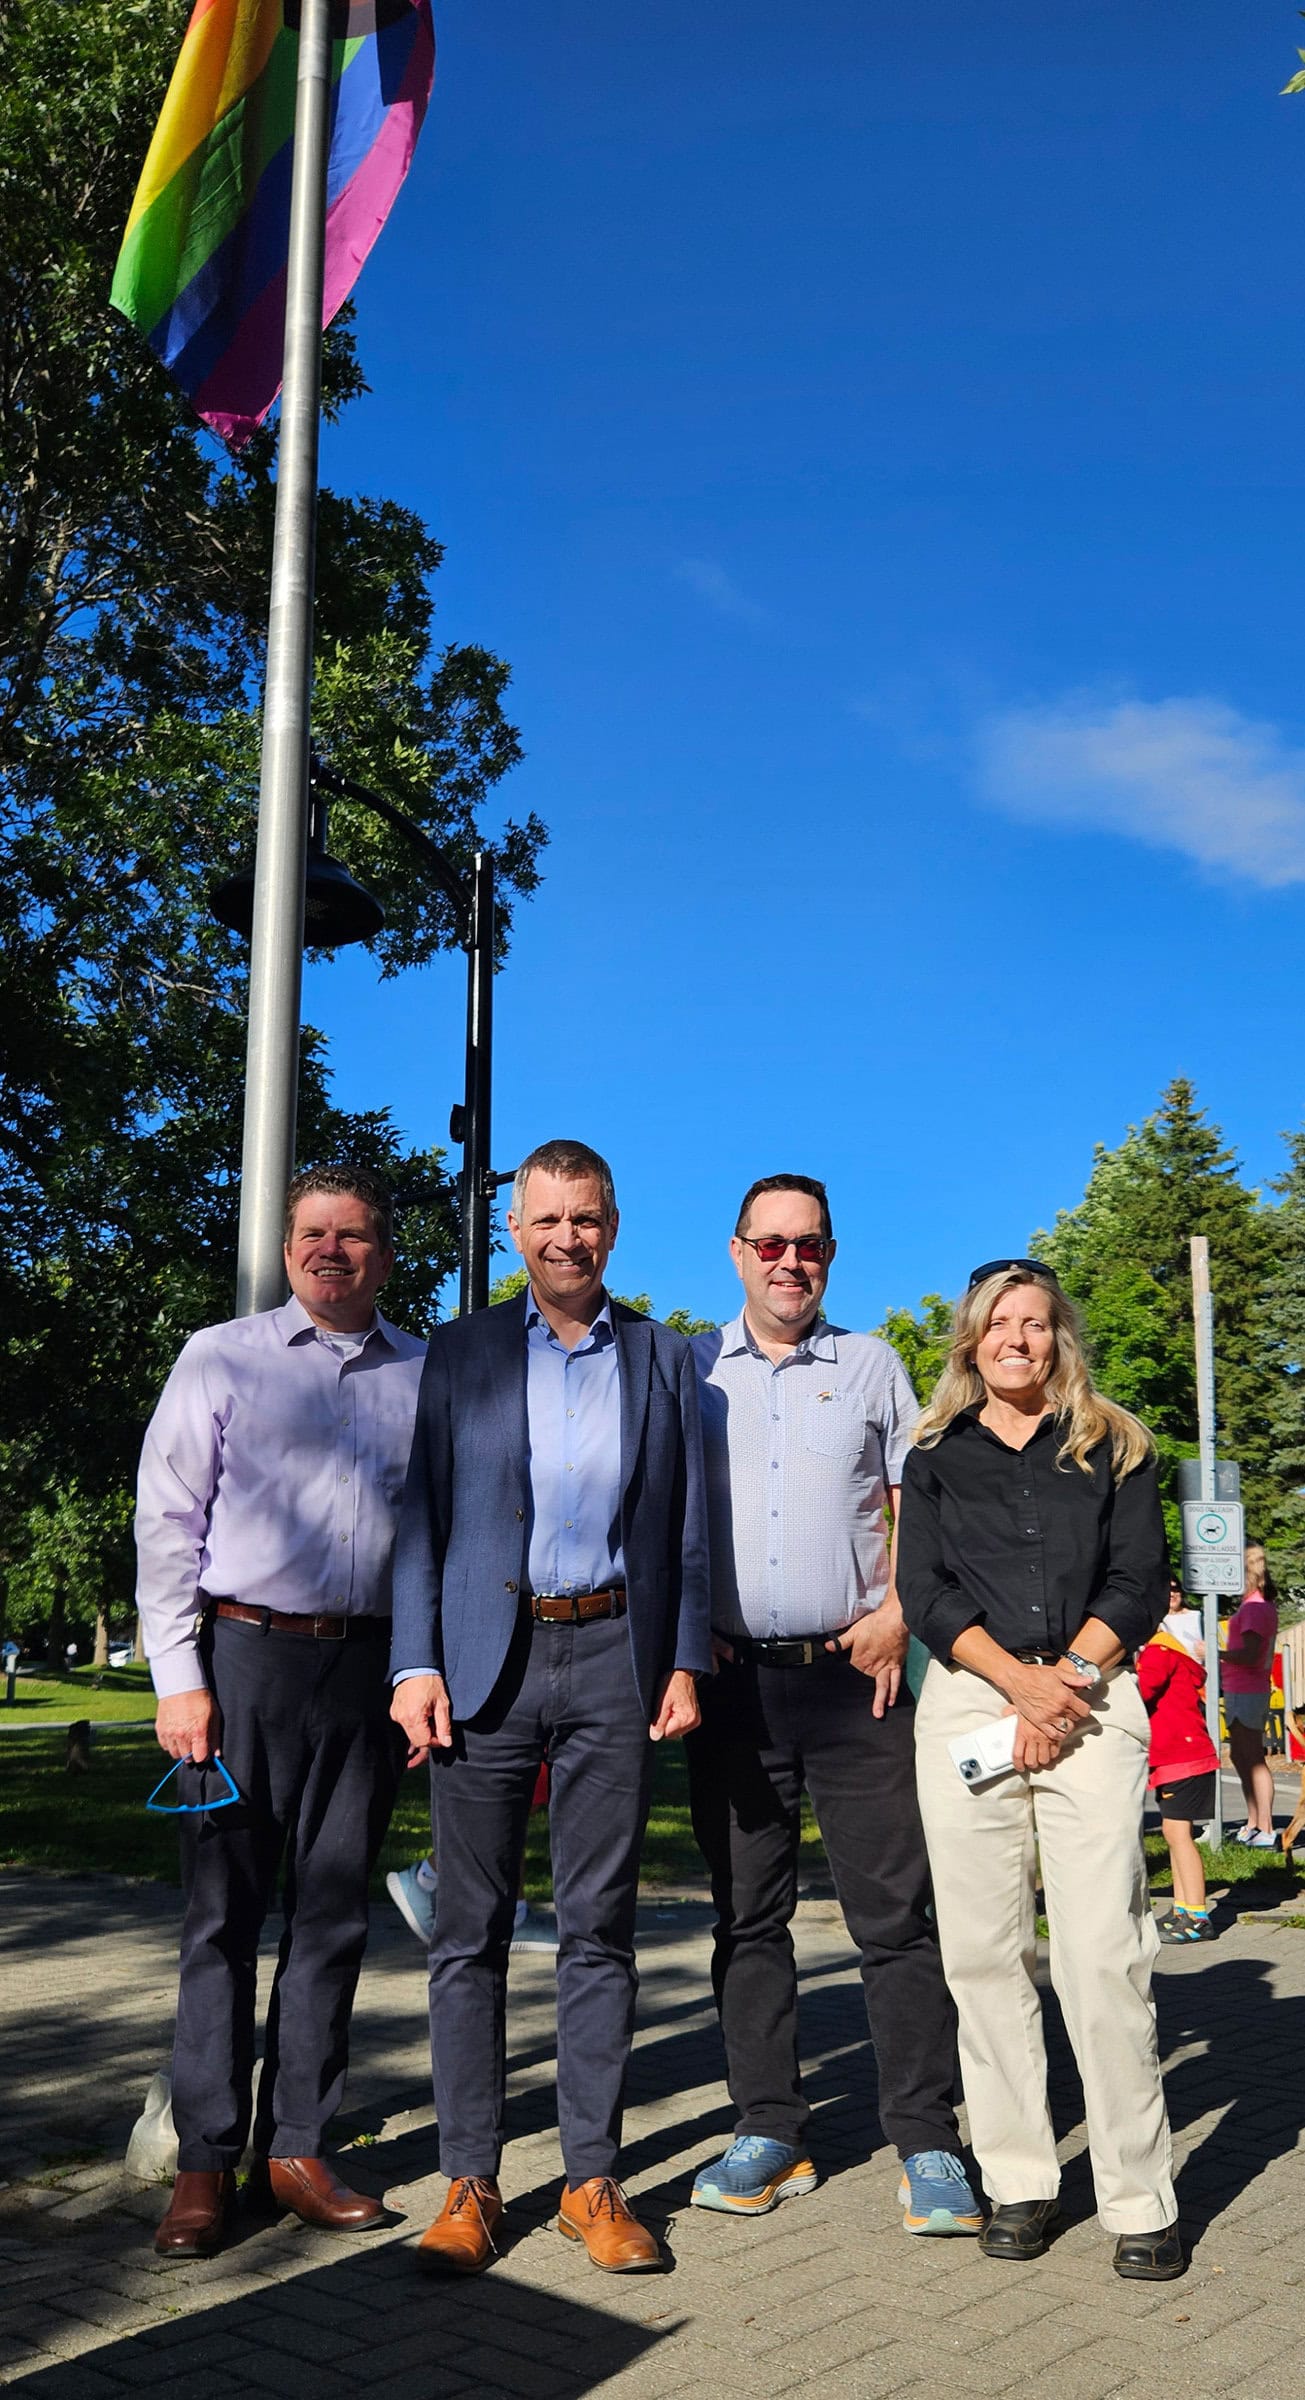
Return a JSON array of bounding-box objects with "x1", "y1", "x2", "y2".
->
[{"x1": 686, "y1": 1654, "x2": 957, "y2": 2158}]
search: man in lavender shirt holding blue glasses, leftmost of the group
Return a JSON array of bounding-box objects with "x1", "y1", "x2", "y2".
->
[{"x1": 137, "y1": 1166, "x2": 425, "y2": 2258}]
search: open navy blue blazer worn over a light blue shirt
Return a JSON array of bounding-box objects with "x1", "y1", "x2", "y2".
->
[{"x1": 391, "y1": 1294, "x2": 712, "y2": 1721}]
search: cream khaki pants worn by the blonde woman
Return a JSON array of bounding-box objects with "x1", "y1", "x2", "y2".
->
[{"x1": 916, "y1": 1661, "x2": 1178, "y2": 2234}]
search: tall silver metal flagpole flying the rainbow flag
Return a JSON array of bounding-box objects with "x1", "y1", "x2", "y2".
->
[{"x1": 235, "y1": 0, "x2": 331, "y2": 1318}]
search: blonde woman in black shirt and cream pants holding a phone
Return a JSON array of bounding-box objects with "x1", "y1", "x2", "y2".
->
[{"x1": 897, "y1": 1260, "x2": 1185, "y2": 2280}]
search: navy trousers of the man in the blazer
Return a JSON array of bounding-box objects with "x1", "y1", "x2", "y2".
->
[{"x1": 429, "y1": 1610, "x2": 653, "y2": 2186}]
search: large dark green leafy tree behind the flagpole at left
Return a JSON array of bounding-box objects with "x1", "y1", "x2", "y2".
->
[{"x1": 0, "y1": 0, "x2": 545, "y2": 1641}]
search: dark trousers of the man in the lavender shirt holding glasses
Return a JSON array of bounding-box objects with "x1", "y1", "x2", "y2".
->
[{"x1": 173, "y1": 1618, "x2": 408, "y2": 2167}]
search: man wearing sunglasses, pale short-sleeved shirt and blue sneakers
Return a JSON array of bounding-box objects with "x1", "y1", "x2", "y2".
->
[{"x1": 686, "y1": 1176, "x2": 984, "y2": 2234}]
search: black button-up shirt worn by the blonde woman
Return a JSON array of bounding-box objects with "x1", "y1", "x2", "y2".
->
[{"x1": 897, "y1": 1409, "x2": 1168, "y2": 1663}]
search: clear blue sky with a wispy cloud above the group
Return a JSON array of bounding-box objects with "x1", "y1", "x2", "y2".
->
[{"x1": 305, "y1": 0, "x2": 1305, "y2": 1325}]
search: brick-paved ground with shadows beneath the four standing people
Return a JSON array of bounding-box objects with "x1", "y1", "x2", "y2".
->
[{"x1": 0, "y1": 1874, "x2": 1305, "y2": 2400}]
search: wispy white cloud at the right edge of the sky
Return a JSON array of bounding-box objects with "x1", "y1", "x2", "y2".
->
[{"x1": 976, "y1": 694, "x2": 1305, "y2": 890}]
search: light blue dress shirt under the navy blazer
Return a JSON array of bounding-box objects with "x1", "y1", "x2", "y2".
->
[{"x1": 525, "y1": 1301, "x2": 626, "y2": 1594}]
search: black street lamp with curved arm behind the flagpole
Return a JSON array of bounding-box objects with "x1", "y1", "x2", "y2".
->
[{"x1": 211, "y1": 758, "x2": 511, "y2": 1315}]
